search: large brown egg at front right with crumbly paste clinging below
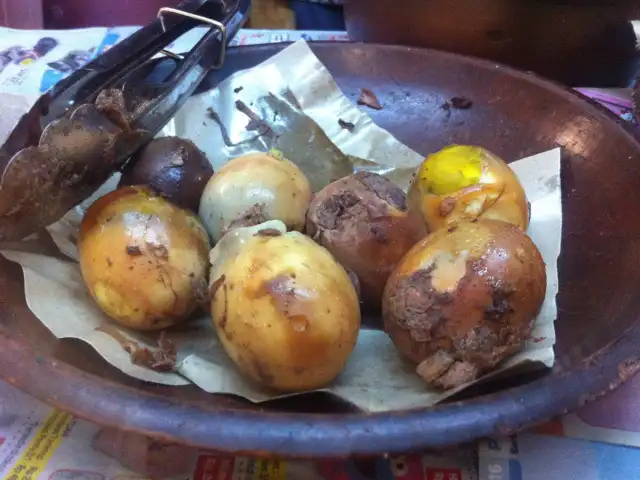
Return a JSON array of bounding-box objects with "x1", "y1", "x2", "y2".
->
[{"x1": 382, "y1": 220, "x2": 547, "y2": 389}]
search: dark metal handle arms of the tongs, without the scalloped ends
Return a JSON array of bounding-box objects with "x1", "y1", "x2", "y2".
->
[{"x1": 0, "y1": 0, "x2": 251, "y2": 166}]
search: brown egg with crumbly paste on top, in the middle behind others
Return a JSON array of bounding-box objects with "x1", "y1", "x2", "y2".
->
[{"x1": 306, "y1": 172, "x2": 427, "y2": 311}]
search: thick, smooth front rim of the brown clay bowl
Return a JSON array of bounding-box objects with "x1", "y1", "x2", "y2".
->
[{"x1": 5, "y1": 324, "x2": 640, "y2": 458}]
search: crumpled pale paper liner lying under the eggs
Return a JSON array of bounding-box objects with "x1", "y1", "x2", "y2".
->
[{"x1": 1, "y1": 41, "x2": 562, "y2": 411}]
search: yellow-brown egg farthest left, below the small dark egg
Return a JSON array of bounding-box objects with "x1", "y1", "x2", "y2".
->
[{"x1": 78, "y1": 187, "x2": 210, "y2": 330}]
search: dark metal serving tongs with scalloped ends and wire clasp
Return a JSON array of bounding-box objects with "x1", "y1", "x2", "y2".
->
[{"x1": 0, "y1": 0, "x2": 250, "y2": 241}]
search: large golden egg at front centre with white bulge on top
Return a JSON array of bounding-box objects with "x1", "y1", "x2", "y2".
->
[{"x1": 211, "y1": 221, "x2": 360, "y2": 392}]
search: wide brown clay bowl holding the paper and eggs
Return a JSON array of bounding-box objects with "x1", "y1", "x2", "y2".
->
[{"x1": 0, "y1": 44, "x2": 640, "y2": 457}]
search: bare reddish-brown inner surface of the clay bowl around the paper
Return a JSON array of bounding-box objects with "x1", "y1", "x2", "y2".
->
[{"x1": 0, "y1": 44, "x2": 640, "y2": 452}]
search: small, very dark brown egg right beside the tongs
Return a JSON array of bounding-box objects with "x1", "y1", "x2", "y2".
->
[{"x1": 120, "y1": 137, "x2": 213, "y2": 212}]
